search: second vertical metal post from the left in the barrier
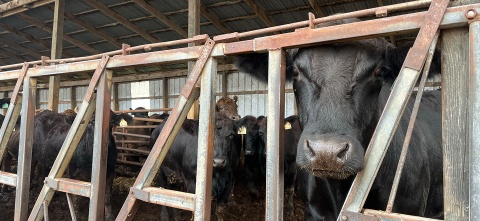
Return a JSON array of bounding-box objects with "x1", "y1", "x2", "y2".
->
[{"x1": 88, "y1": 70, "x2": 113, "y2": 221}]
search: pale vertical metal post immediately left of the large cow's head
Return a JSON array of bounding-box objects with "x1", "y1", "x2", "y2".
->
[{"x1": 265, "y1": 49, "x2": 285, "y2": 221}]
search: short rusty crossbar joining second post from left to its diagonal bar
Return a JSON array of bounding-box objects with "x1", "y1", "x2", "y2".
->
[{"x1": 45, "y1": 177, "x2": 92, "y2": 197}]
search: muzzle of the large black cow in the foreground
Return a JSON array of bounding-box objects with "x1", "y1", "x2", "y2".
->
[{"x1": 303, "y1": 134, "x2": 364, "y2": 179}]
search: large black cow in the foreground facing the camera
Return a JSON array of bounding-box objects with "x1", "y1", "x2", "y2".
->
[{"x1": 236, "y1": 19, "x2": 443, "y2": 220}]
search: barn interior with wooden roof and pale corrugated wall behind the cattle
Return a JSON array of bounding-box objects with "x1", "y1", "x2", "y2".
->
[{"x1": 0, "y1": 0, "x2": 441, "y2": 220}]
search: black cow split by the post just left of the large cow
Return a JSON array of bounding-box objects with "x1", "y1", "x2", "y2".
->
[{"x1": 257, "y1": 115, "x2": 302, "y2": 216}]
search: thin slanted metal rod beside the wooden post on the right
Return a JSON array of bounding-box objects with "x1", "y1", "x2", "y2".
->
[{"x1": 386, "y1": 31, "x2": 440, "y2": 213}]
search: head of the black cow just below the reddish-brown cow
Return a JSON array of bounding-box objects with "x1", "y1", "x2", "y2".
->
[{"x1": 213, "y1": 113, "x2": 236, "y2": 168}]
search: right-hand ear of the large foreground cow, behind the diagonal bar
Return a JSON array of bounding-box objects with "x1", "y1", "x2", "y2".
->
[{"x1": 375, "y1": 43, "x2": 441, "y2": 81}]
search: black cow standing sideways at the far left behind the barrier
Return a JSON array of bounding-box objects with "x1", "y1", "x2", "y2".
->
[{"x1": 4, "y1": 110, "x2": 132, "y2": 220}]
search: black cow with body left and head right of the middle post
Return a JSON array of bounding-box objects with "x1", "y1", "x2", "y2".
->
[{"x1": 150, "y1": 113, "x2": 238, "y2": 220}]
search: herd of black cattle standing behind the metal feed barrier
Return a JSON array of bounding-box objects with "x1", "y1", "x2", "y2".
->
[{"x1": 3, "y1": 19, "x2": 443, "y2": 220}]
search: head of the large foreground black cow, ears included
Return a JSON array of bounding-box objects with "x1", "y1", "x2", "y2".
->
[{"x1": 236, "y1": 19, "x2": 439, "y2": 179}]
